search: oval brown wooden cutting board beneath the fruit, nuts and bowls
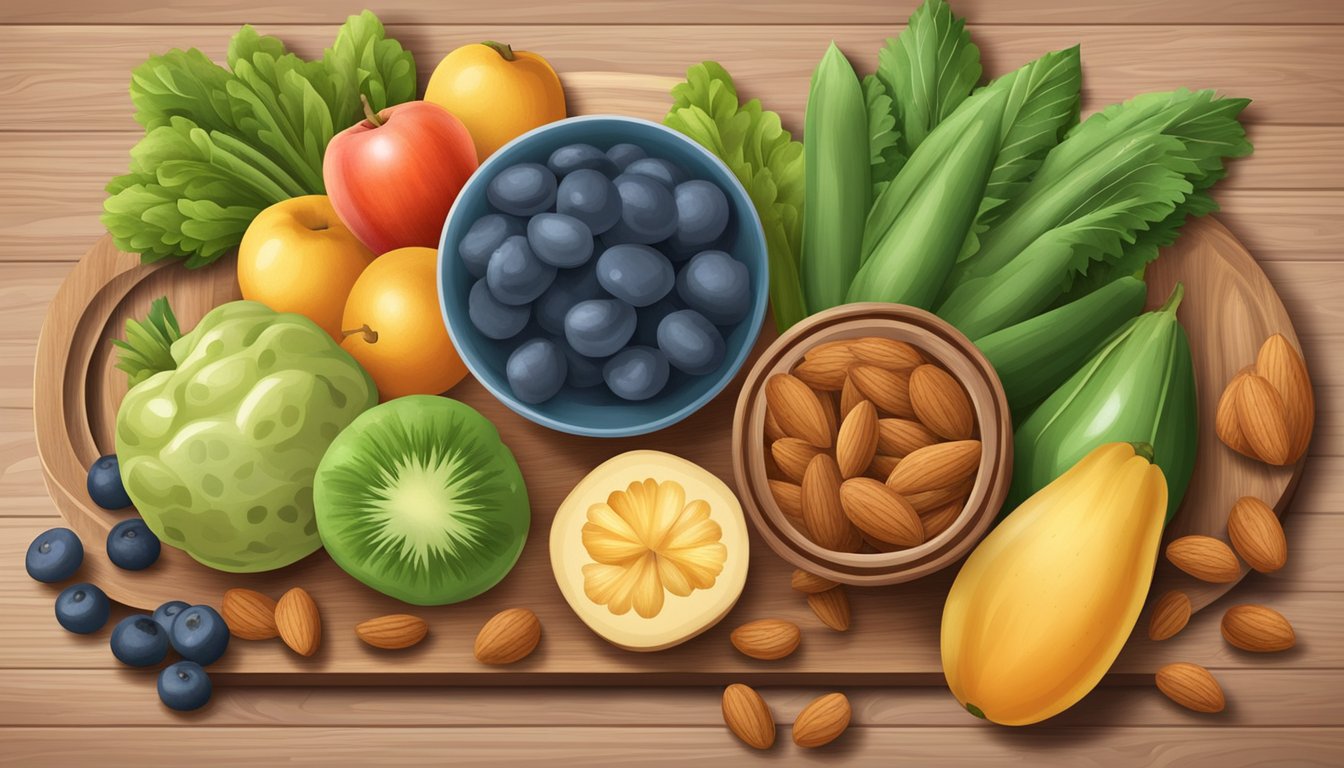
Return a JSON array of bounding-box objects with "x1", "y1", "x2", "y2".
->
[{"x1": 34, "y1": 73, "x2": 1301, "y2": 685}]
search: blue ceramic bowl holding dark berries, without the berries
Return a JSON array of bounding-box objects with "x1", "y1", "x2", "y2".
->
[{"x1": 438, "y1": 116, "x2": 769, "y2": 437}]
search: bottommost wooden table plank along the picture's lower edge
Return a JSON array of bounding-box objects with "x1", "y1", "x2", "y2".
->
[{"x1": 0, "y1": 716, "x2": 1344, "y2": 768}]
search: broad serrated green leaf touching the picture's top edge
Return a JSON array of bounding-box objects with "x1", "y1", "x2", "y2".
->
[{"x1": 878, "y1": 0, "x2": 981, "y2": 157}]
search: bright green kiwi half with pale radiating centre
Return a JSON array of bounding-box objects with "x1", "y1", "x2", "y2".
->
[{"x1": 313, "y1": 395, "x2": 531, "y2": 605}]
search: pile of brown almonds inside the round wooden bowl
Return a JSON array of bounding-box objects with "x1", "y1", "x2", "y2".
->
[{"x1": 765, "y1": 336, "x2": 981, "y2": 553}]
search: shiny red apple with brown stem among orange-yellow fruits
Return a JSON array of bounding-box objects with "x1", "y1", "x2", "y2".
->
[{"x1": 323, "y1": 101, "x2": 476, "y2": 253}]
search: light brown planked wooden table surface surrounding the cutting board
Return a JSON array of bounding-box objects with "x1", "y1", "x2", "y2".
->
[{"x1": 0, "y1": 0, "x2": 1344, "y2": 767}]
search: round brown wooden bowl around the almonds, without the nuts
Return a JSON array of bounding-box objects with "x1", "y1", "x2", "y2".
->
[{"x1": 732, "y1": 303, "x2": 1012, "y2": 586}]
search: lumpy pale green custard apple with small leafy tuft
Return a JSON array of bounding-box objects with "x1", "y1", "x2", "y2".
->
[{"x1": 117, "y1": 300, "x2": 378, "y2": 573}]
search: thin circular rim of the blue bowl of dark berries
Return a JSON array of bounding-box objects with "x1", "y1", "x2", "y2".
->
[{"x1": 434, "y1": 114, "x2": 770, "y2": 437}]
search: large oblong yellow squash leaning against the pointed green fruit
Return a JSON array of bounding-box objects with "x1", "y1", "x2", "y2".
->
[{"x1": 942, "y1": 443, "x2": 1167, "y2": 725}]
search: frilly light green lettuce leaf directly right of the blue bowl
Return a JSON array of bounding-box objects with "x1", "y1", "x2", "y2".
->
[{"x1": 663, "y1": 62, "x2": 806, "y2": 331}]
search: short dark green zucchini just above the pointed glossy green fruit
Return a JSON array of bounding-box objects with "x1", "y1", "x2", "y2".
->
[{"x1": 976, "y1": 277, "x2": 1148, "y2": 417}]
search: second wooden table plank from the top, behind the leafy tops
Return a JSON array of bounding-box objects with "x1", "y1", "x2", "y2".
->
[{"x1": 0, "y1": 25, "x2": 1344, "y2": 130}]
